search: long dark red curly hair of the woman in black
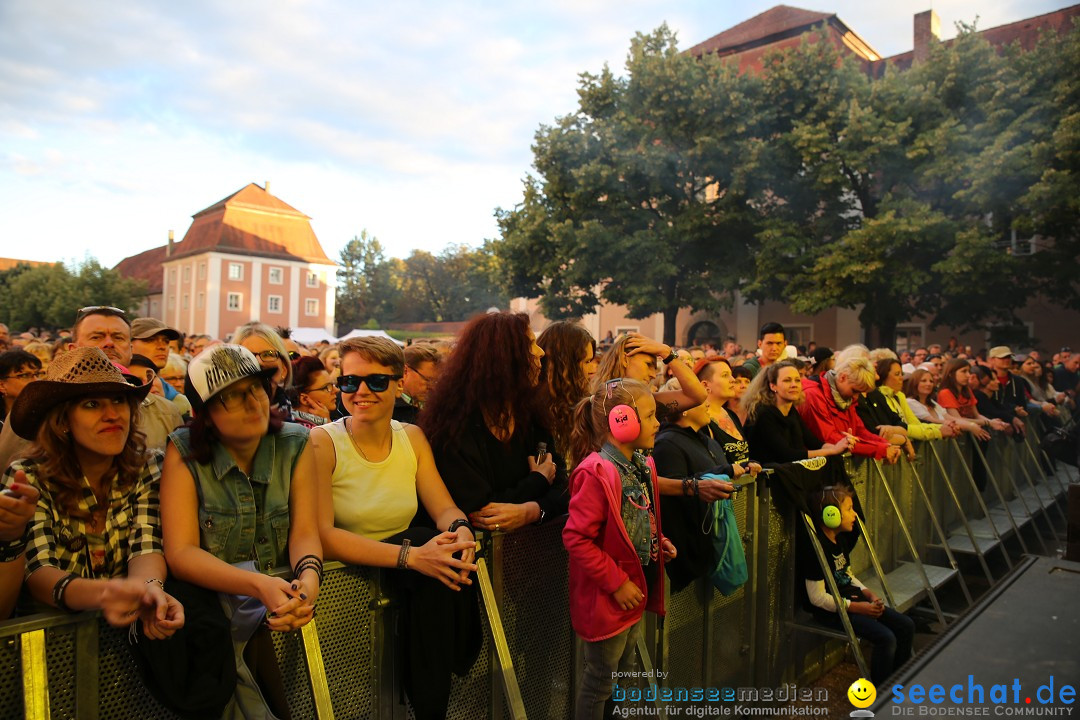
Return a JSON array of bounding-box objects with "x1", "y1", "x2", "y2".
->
[{"x1": 418, "y1": 312, "x2": 546, "y2": 450}]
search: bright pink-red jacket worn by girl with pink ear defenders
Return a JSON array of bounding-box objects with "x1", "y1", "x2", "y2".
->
[{"x1": 563, "y1": 452, "x2": 664, "y2": 642}]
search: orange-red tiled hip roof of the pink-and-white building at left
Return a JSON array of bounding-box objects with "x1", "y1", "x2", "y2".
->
[{"x1": 170, "y1": 182, "x2": 333, "y2": 264}]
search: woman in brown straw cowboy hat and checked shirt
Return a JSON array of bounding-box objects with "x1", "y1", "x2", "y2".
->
[{"x1": 0, "y1": 348, "x2": 184, "y2": 639}]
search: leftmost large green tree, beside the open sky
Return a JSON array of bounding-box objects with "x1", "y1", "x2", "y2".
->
[{"x1": 496, "y1": 26, "x2": 758, "y2": 342}]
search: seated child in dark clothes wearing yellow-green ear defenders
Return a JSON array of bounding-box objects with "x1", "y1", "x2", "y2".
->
[{"x1": 799, "y1": 486, "x2": 915, "y2": 688}]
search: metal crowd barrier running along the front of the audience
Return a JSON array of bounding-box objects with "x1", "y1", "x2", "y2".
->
[{"x1": 0, "y1": 418, "x2": 1075, "y2": 720}]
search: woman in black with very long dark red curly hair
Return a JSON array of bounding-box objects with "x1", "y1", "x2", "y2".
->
[{"x1": 419, "y1": 312, "x2": 569, "y2": 532}]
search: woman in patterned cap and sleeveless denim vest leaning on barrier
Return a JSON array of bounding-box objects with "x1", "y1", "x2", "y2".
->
[{"x1": 161, "y1": 344, "x2": 323, "y2": 717}]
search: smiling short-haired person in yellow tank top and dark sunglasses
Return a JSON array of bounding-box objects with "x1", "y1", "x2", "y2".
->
[{"x1": 311, "y1": 337, "x2": 481, "y2": 718}]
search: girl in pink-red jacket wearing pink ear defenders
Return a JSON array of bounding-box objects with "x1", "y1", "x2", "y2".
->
[{"x1": 563, "y1": 378, "x2": 675, "y2": 720}]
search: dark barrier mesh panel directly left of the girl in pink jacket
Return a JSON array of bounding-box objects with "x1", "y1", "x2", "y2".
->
[{"x1": 500, "y1": 520, "x2": 575, "y2": 718}]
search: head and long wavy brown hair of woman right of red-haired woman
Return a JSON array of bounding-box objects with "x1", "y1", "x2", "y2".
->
[{"x1": 537, "y1": 321, "x2": 596, "y2": 464}]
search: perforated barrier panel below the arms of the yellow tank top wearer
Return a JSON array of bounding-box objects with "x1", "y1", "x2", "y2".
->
[{"x1": 317, "y1": 566, "x2": 378, "y2": 718}]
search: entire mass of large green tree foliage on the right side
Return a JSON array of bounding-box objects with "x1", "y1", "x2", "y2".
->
[{"x1": 497, "y1": 21, "x2": 1080, "y2": 344}]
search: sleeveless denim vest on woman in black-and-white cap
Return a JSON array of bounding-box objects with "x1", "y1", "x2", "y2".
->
[{"x1": 168, "y1": 422, "x2": 308, "y2": 572}]
